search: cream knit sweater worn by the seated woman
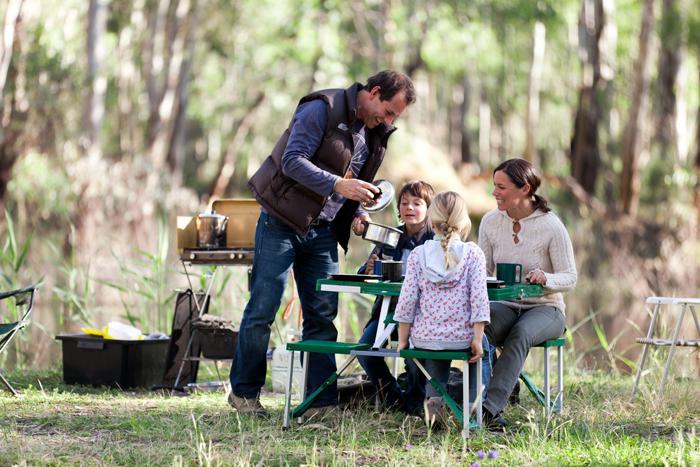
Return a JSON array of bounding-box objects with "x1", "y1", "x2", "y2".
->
[{"x1": 479, "y1": 209, "x2": 577, "y2": 313}]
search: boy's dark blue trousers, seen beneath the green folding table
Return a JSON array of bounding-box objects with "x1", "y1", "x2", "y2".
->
[{"x1": 357, "y1": 318, "x2": 425, "y2": 414}]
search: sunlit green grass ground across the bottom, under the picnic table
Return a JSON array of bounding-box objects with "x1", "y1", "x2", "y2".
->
[{"x1": 0, "y1": 370, "x2": 700, "y2": 466}]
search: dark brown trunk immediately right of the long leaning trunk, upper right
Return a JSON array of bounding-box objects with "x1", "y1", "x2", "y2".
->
[{"x1": 654, "y1": 0, "x2": 682, "y2": 164}]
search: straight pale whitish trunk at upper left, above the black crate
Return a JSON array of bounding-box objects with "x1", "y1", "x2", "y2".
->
[{"x1": 83, "y1": 0, "x2": 107, "y2": 160}]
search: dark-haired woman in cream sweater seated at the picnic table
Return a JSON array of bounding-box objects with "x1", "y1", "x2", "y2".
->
[{"x1": 479, "y1": 159, "x2": 577, "y2": 430}]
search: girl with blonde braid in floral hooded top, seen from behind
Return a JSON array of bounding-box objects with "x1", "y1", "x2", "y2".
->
[{"x1": 394, "y1": 191, "x2": 491, "y2": 424}]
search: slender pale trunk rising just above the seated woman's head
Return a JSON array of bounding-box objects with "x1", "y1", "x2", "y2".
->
[{"x1": 524, "y1": 21, "x2": 546, "y2": 165}]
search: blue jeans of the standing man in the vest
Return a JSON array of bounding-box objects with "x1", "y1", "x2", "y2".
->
[{"x1": 231, "y1": 212, "x2": 338, "y2": 406}]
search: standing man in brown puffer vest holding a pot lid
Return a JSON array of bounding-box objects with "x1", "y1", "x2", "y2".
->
[{"x1": 228, "y1": 70, "x2": 416, "y2": 416}]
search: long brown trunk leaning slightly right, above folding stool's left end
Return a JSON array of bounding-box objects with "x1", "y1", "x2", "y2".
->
[{"x1": 620, "y1": 0, "x2": 654, "y2": 215}]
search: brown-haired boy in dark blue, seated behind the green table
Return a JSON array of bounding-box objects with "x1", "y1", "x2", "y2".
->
[{"x1": 357, "y1": 180, "x2": 435, "y2": 414}]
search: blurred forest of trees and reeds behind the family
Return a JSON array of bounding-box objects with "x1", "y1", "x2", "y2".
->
[{"x1": 0, "y1": 0, "x2": 700, "y2": 374}]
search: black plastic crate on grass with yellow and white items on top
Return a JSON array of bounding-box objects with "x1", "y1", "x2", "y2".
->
[{"x1": 56, "y1": 334, "x2": 170, "y2": 389}]
